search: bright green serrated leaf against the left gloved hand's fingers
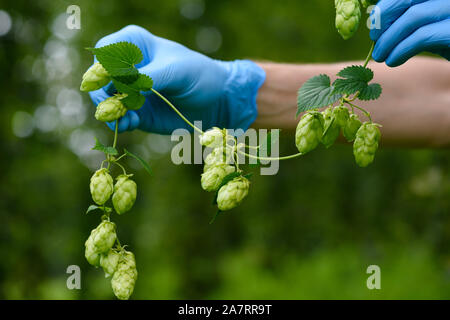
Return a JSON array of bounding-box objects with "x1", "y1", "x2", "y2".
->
[{"x1": 88, "y1": 42, "x2": 143, "y2": 82}]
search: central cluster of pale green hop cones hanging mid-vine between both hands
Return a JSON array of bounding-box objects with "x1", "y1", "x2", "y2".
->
[{"x1": 200, "y1": 127, "x2": 250, "y2": 211}]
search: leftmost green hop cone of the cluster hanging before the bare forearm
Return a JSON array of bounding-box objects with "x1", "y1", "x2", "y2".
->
[{"x1": 295, "y1": 111, "x2": 324, "y2": 153}]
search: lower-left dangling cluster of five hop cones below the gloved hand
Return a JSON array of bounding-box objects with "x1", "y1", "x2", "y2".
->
[{"x1": 85, "y1": 168, "x2": 137, "y2": 299}]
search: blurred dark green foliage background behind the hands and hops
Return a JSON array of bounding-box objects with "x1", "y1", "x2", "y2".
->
[{"x1": 0, "y1": 0, "x2": 450, "y2": 299}]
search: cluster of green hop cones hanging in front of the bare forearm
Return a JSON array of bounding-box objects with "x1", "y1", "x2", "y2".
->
[{"x1": 295, "y1": 106, "x2": 381, "y2": 167}]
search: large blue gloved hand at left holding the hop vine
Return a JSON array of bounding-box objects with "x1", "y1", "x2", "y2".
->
[{"x1": 90, "y1": 25, "x2": 265, "y2": 134}]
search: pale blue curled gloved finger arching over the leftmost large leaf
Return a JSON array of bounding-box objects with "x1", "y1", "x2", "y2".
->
[{"x1": 94, "y1": 25, "x2": 155, "y2": 68}]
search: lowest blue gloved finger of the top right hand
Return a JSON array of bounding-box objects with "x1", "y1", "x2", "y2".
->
[{"x1": 386, "y1": 19, "x2": 450, "y2": 67}]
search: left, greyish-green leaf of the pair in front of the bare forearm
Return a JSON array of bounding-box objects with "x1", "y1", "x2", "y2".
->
[{"x1": 297, "y1": 74, "x2": 342, "y2": 116}]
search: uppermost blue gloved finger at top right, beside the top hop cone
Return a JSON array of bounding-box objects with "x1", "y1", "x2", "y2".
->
[{"x1": 370, "y1": 0, "x2": 429, "y2": 41}]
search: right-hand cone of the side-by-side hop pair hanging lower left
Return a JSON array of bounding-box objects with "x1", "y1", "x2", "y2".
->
[{"x1": 112, "y1": 174, "x2": 137, "y2": 214}]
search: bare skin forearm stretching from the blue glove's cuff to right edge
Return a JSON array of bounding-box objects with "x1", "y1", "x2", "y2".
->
[{"x1": 254, "y1": 58, "x2": 450, "y2": 147}]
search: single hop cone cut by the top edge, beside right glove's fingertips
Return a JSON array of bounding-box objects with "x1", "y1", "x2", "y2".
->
[{"x1": 334, "y1": 0, "x2": 361, "y2": 40}]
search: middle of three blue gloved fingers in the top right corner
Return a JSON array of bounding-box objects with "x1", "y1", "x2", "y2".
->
[{"x1": 373, "y1": 0, "x2": 450, "y2": 62}]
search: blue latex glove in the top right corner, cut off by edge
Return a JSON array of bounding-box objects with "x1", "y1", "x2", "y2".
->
[{"x1": 370, "y1": 0, "x2": 450, "y2": 67}]
